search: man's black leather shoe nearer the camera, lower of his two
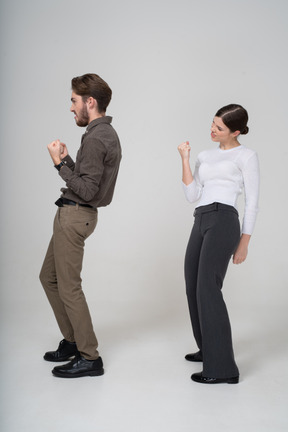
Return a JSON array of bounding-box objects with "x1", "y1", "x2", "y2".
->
[{"x1": 52, "y1": 354, "x2": 104, "y2": 378}]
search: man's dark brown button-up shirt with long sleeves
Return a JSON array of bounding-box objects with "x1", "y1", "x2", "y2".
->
[{"x1": 59, "y1": 116, "x2": 121, "y2": 207}]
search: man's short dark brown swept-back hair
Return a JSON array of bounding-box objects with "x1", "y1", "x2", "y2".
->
[{"x1": 71, "y1": 74, "x2": 112, "y2": 113}]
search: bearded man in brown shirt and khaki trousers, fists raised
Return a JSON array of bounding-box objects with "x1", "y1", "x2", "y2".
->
[{"x1": 40, "y1": 74, "x2": 121, "y2": 378}]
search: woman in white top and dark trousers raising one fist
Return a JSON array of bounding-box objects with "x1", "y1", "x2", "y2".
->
[{"x1": 178, "y1": 104, "x2": 259, "y2": 384}]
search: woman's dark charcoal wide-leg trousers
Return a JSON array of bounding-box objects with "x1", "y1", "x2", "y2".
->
[{"x1": 185, "y1": 203, "x2": 240, "y2": 378}]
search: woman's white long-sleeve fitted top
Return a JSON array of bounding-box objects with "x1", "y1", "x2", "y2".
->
[{"x1": 183, "y1": 145, "x2": 259, "y2": 235}]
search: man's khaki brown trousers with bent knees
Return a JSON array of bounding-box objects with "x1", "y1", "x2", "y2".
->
[{"x1": 40, "y1": 204, "x2": 99, "y2": 360}]
